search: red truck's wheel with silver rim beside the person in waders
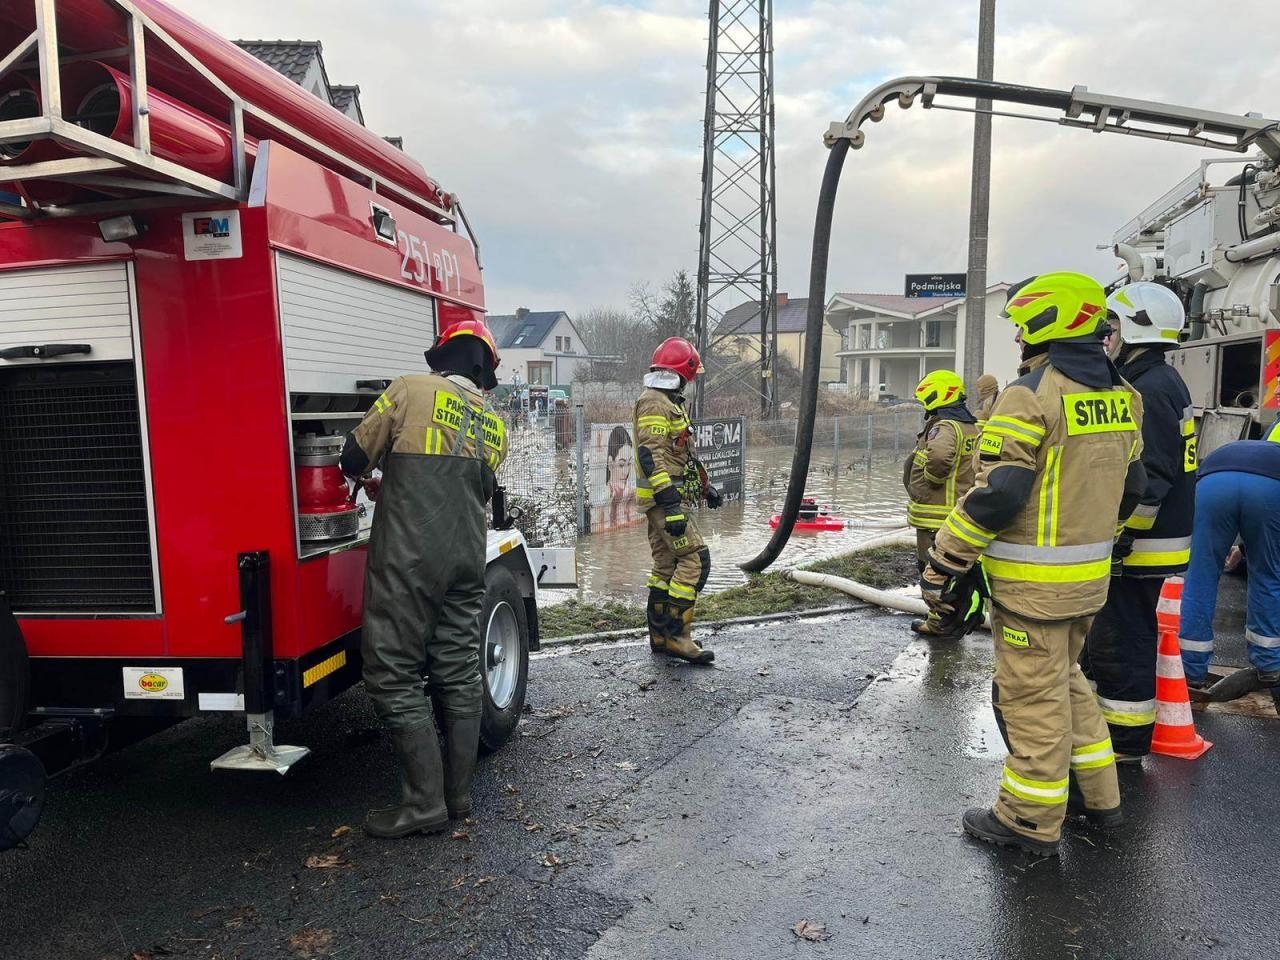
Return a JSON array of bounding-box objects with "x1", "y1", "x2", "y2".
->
[{"x1": 480, "y1": 567, "x2": 529, "y2": 753}]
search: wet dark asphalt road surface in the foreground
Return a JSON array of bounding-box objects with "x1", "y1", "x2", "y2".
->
[{"x1": 0, "y1": 586, "x2": 1280, "y2": 960}]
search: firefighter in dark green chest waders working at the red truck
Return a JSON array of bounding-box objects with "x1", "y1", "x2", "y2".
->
[{"x1": 342, "y1": 320, "x2": 507, "y2": 837}]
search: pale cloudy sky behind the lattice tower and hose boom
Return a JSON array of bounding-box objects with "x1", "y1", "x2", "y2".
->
[{"x1": 174, "y1": 0, "x2": 1280, "y2": 312}]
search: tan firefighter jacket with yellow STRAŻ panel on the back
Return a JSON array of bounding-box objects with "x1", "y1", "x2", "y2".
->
[{"x1": 931, "y1": 340, "x2": 1146, "y2": 621}]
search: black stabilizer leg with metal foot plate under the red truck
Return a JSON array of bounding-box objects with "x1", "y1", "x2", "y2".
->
[{"x1": 209, "y1": 550, "x2": 311, "y2": 776}]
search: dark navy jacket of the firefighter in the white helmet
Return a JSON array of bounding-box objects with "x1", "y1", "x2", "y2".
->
[{"x1": 1120, "y1": 348, "x2": 1197, "y2": 577}]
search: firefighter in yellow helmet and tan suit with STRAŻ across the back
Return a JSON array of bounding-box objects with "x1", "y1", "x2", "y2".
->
[{"x1": 920, "y1": 273, "x2": 1146, "y2": 856}]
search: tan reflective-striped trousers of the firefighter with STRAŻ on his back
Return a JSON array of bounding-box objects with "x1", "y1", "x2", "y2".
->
[{"x1": 991, "y1": 604, "x2": 1120, "y2": 841}]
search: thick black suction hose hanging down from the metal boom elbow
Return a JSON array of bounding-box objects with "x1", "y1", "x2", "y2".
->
[{"x1": 742, "y1": 138, "x2": 849, "y2": 573}]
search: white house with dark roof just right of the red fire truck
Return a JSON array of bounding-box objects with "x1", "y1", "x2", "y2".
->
[{"x1": 485, "y1": 307, "x2": 588, "y2": 387}]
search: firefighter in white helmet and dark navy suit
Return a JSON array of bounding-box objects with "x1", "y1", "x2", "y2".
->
[{"x1": 1080, "y1": 282, "x2": 1197, "y2": 763}]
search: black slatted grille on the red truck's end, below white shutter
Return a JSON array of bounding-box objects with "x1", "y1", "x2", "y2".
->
[{"x1": 0, "y1": 361, "x2": 156, "y2": 613}]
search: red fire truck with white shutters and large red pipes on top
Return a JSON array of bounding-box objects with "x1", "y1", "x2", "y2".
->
[{"x1": 0, "y1": 0, "x2": 575, "y2": 849}]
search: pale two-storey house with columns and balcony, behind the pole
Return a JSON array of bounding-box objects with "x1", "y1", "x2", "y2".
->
[{"x1": 826, "y1": 283, "x2": 1018, "y2": 399}]
